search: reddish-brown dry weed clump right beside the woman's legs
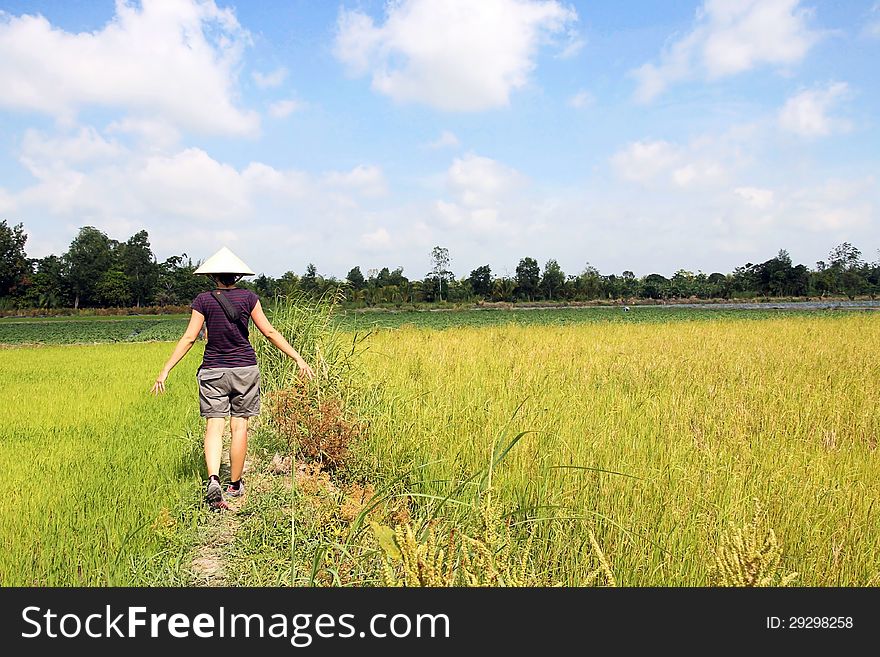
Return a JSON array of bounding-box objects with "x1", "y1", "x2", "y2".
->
[{"x1": 268, "y1": 387, "x2": 361, "y2": 470}]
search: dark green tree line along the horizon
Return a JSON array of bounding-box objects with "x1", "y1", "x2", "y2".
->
[{"x1": 0, "y1": 221, "x2": 880, "y2": 309}]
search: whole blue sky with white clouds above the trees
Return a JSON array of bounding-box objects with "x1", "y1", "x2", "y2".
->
[{"x1": 0, "y1": 0, "x2": 880, "y2": 277}]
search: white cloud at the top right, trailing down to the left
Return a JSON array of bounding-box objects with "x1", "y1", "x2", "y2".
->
[{"x1": 632, "y1": 0, "x2": 820, "y2": 102}]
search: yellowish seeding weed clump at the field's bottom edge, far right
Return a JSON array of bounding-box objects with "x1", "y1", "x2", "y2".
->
[{"x1": 711, "y1": 501, "x2": 798, "y2": 587}]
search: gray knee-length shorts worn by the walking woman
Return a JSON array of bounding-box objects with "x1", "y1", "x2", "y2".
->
[{"x1": 196, "y1": 365, "x2": 260, "y2": 417}]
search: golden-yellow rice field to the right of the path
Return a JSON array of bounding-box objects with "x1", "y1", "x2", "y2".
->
[{"x1": 350, "y1": 315, "x2": 880, "y2": 586}]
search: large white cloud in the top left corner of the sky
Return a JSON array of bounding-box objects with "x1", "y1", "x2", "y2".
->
[{"x1": 0, "y1": 0, "x2": 259, "y2": 135}]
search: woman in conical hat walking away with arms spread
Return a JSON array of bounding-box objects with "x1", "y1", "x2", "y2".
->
[{"x1": 152, "y1": 246, "x2": 314, "y2": 510}]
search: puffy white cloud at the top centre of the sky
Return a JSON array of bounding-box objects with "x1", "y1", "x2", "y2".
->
[{"x1": 334, "y1": 0, "x2": 577, "y2": 111}]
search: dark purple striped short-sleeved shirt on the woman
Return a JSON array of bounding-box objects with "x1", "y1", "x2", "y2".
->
[{"x1": 190, "y1": 288, "x2": 260, "y2": 369}]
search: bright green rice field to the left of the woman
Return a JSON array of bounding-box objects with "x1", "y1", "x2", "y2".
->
[{"x1": 0, "y1": 343, "x2": 201, "y2": 586}]
